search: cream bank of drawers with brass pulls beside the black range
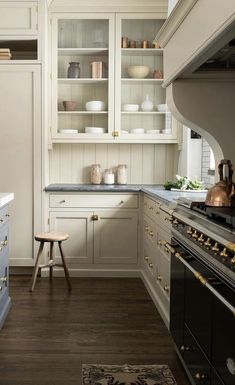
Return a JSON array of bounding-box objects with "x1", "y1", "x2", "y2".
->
[{"x1": 142, "y1": 194, "x2": 171, "y2": 326}]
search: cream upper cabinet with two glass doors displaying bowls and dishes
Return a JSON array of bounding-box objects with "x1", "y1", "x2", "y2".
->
[{"x1": 48, "y1": 12, "x2": 178, "y2": 143}]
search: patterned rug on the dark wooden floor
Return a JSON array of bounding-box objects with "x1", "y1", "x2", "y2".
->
[{"x1": 82, "y1": 365, "x2": 176, "y2": 385}]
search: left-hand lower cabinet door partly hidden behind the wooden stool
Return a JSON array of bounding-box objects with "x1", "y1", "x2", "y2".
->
[{"x1": 50, "y1": 211, "x2": 93, "y2": 267}]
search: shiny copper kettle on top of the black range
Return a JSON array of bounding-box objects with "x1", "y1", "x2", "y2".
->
[{"x1": 205, "y1": 159, "x2": 235, "y2": 207}]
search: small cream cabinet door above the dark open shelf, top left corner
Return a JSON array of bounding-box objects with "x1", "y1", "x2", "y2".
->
[{"x1": 0, "y1": 1, "x2": 37, "y2": 35}]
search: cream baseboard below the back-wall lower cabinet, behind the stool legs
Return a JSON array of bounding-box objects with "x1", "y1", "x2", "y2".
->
[{"x1": 41, "y1": 268, "x2": 140, "y2": 278}]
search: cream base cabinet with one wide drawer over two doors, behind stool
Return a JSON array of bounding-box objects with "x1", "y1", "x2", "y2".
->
[{"x1": 49, "y1": 193, "x2": 138, "y2": 269}]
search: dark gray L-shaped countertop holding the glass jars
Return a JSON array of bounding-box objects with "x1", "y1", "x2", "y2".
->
[{"x1": 45, "y1": 183, "x2": 206, "y2": 204}]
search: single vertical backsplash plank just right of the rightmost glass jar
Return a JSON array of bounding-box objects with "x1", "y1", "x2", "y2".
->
[{"x1": 130, "y1": 144, "x2": 143, "y2": 183}]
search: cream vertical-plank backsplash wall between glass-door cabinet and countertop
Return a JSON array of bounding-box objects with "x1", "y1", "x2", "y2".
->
[{"x1": 50, "y1": 144, "x2": 178, "y2": 184}]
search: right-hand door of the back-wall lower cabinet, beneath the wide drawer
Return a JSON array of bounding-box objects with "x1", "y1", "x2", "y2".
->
[{"x1": 94, "y1": 210, "x2": 138, "y2": 264}]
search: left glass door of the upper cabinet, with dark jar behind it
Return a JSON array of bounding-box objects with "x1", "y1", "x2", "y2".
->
[{"x1": 51, "y1": 13, "x2": 115, "y2": 142}]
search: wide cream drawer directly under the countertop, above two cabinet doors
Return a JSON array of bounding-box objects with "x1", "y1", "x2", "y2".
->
[{"x1": 50, "y1": 193, "x2": 139, "y2": 209}]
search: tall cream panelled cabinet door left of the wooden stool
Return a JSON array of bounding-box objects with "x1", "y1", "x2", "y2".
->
[{"x1": 0, "y1": 65, "x2": 42, "y2": 266}]
